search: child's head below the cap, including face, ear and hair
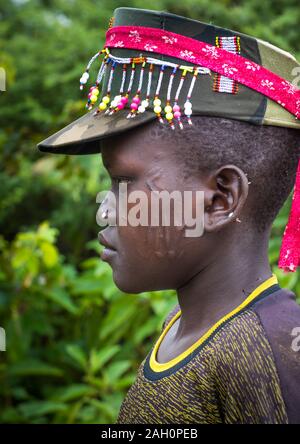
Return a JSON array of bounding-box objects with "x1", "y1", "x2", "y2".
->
[{"x1": 101, "y1": 115, "x2": 300, "y2": 293}]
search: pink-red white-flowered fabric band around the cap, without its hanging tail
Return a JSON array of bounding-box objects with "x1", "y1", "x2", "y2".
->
[{"x1": 104, "y1": 26, "x2": 300, "y2": 119}]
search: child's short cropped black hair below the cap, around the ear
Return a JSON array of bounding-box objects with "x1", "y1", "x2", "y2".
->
[{"x1": 149, "y1": 115, "x2": 300, "y2": 232}]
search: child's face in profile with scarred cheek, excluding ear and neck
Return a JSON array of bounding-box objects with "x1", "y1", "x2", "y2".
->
[{"x1": 99, "y1": 125, "x2": 209, "y2": 293}]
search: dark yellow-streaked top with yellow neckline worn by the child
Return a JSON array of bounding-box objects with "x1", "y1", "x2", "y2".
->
[{"x1": 116, "y1": 275, "x2": 300, "y2": 424}]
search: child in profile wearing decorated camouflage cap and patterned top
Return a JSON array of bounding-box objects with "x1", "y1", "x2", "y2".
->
[{"x1": 39, "y1": 8, "x2": 300, "y2": 423}]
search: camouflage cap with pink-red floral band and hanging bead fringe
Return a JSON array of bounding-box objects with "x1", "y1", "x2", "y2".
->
[{"x1": 38, "y1": 7, "x2": 300, "y2": 154}]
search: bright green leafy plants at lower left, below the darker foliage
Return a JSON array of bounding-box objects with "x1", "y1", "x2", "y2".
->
[{"x1": 0, "y1": 222, "x2": 175, "y2": 424}]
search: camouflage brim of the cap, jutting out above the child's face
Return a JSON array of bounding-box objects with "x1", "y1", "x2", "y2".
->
[{"x1": 37, "y1": 109, "x2": 156, "y2": 154}]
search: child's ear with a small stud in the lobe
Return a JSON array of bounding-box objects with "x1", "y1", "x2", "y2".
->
[{"x1": 204, "y1": 165, "x2": 249, "y2": 232}]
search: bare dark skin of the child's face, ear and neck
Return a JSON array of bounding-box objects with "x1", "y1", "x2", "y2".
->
[{"x1": 100, "y1": 125, "x2": 272, "y2": 363}]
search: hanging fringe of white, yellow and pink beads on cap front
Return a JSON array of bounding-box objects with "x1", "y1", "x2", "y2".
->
[{"x1": 80, "y1": 48, "x2": 211, "y2": 130}]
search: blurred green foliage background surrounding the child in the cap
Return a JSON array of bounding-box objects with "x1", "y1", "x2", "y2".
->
[{"x1": 0, "y1": 0, "x2": 300, "y2": 424}]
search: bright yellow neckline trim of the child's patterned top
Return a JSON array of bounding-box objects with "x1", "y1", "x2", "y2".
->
[{"x1": 149, "y1": 274, "x2": 278, "y2": 372}]
